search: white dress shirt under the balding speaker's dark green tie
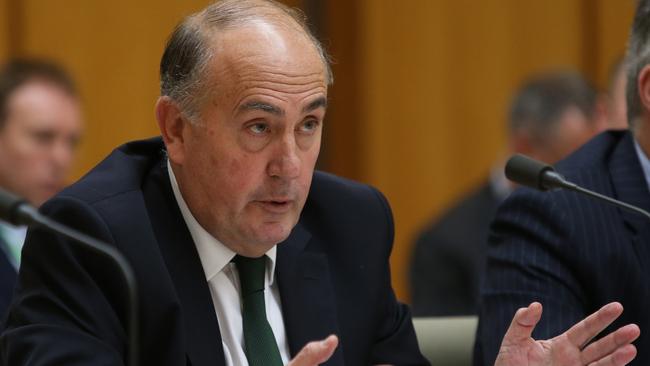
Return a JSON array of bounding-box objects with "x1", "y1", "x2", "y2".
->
[{"x1": 167, "y1": 161, "x2": 289, "y2": 366}]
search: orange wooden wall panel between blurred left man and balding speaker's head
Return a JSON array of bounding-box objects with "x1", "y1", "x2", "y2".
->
[{"x1": 18, "y1": 0, "x2": 208, "y2": 178}]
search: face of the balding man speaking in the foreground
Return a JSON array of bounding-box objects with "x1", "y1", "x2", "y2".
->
[{"x1": 170, "y1": 23, "x2": 327, "y2": 257}]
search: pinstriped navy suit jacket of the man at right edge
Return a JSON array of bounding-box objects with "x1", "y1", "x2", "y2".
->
[{"x1": 475, "y1": 131, "x2": 650, "y2": 366}]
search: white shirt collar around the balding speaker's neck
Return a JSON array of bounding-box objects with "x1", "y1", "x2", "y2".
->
[{"x1": 167, "y1": 160, "x2": 277, "y2": 286}]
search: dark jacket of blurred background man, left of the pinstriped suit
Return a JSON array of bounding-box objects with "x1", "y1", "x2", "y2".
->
[{"x1": 410, "y1": 182, "x2": 501, "y2": 316}]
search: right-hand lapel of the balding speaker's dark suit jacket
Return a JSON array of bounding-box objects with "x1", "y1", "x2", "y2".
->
[{"x1": 276, "y1": 223, "x2": 343, "y2": 365}]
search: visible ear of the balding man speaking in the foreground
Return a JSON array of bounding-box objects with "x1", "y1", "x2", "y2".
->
[{"x1": 156, "y1": 96, "x2": 189, "y2": 165}]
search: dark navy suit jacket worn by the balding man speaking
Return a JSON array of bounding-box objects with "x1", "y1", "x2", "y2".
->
[{"x1": 0, "y1": 139, "x2": 427, "y2": 366}]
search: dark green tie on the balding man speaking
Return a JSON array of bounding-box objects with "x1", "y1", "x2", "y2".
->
[{"x1": 234, "y1": 255, "x2": 282, "y2": 366}]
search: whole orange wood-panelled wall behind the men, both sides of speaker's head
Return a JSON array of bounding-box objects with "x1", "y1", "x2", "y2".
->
[{"x1": 10, "y1": 0, "x2": 634, "y2": 299}]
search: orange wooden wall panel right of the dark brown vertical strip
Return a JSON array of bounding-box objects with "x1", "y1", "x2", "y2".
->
[{"x1": 359, "y1": 0, "x2": 629, "y2": 300}]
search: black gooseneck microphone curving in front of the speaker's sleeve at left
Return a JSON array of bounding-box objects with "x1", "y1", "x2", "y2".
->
[{"x1": 0, "y1": 189, "x2": 138, "y2": 366}]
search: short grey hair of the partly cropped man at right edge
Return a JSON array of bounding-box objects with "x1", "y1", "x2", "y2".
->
[{"x1": 625, "y1": 0, "x2": 650, "y2": 128}]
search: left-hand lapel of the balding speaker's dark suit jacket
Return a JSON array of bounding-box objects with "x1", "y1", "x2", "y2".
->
[{"x1": 146, "y1": 165, "x2": 225, "y2": 366}]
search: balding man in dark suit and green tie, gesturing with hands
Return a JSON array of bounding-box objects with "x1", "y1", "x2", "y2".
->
[{"x1": 0, "y1": 0, "x2": 638, "y2": 366}]
